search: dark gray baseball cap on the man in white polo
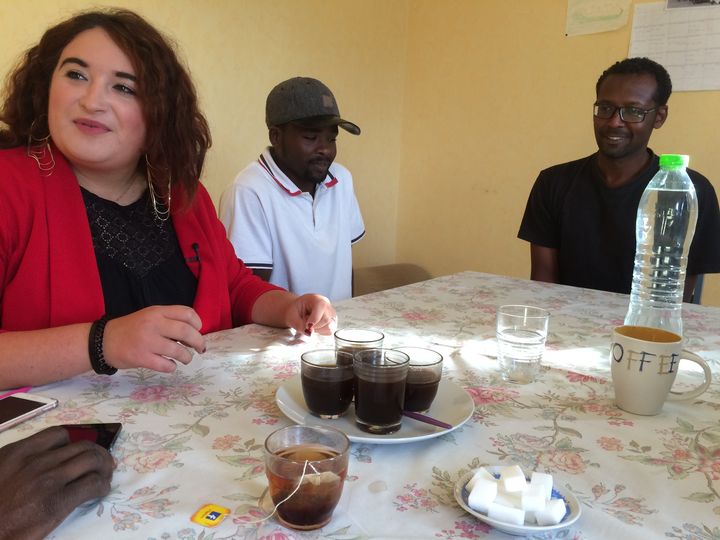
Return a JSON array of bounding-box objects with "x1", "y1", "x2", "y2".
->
[{"x1": 265, "y1": 77, "x2": 360, "y2": 135}]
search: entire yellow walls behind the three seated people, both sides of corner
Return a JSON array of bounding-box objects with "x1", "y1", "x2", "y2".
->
[{"x1": 0, "y1": 0, "x2": 720, "y2": 306}]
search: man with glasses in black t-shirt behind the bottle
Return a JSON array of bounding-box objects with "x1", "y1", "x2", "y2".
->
[{"x1": 518, "y1": 58, "x2": 720, "y2": 301}]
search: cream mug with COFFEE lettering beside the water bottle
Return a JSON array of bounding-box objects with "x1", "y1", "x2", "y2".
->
[{"x1": 610, "y1": 326, "x2": 712, "y2": 415}]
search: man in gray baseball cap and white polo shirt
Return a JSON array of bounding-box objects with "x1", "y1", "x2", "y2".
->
[{"x1": 220, "y1": 77, "x2": 365, "y2": 302}]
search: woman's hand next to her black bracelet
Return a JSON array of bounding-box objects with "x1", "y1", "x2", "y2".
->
[{"x1": 103, "y1": 306, "x2": 205, "y2": 373}]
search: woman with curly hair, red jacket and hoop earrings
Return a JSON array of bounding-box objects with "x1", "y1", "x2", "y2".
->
[{"x1": 0, "y1": 10, "x2": 335, "y2": 388}]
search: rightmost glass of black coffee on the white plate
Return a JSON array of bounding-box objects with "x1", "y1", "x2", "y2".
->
[{"x1": 395, "y1": 347, "x2": 443, "y2": 412}]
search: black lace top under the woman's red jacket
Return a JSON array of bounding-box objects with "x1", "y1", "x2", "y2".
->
[{"x1": 82, "y1": 189, "x2": 197, "y2": 318}]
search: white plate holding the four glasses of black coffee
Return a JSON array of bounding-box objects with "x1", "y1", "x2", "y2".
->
[{"x1": 275, "y1": 375, "x2": 475, "y2": 444}]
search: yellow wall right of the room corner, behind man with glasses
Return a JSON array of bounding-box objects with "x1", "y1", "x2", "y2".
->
[{"x1": 397, "y1": 0, "x2": 720, "y2": 305}]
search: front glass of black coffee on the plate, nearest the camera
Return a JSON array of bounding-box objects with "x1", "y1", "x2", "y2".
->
[{"x1": 353, "y1": 349, "x2": 410, "y2": 435}]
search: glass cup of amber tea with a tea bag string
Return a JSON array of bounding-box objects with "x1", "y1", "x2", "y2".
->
[{"x1": 265, "y1": 426, "x2": 350, "y2": 530}]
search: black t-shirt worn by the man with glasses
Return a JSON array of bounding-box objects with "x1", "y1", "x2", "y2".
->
[{"x1": 518, "y1": 154, "x2": 720, "y2": 293}]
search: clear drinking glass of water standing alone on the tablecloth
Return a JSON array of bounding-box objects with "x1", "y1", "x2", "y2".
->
[{"x1": 496, "y1": 305, "x2": 550, "y2": 384}]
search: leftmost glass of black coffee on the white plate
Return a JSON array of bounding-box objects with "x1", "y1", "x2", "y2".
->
[{"x1": 300, "y1": 349, "x2": 355, "y2": 418}]
